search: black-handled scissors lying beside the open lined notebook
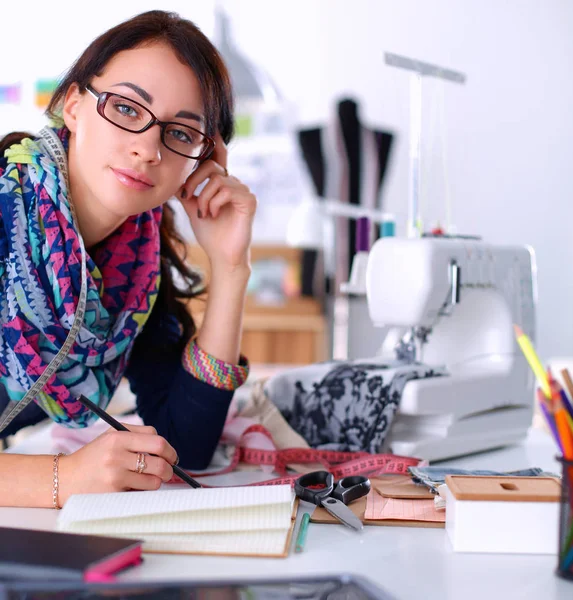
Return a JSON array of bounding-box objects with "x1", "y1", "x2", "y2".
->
[{"x1": 294, "y1": 471, "x2": 370, "y2": 530}]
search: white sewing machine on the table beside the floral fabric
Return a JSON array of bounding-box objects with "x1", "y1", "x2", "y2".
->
[{"x1": 366, "y1": 238, "x2": 536, "y2": 460}]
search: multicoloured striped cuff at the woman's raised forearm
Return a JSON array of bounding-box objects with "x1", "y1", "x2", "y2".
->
[{"x1": 183, "y1": 340, "x2": 249, "y2": 390}]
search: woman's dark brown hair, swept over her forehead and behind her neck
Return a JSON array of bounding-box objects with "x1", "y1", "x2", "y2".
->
[{"x1": 0, "y1": 10, "x2": 234, "y2": 346}]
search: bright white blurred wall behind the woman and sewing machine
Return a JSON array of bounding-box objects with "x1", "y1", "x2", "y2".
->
[{"x1": 0, "y1": 0, "x2": 573, "y2": 358}]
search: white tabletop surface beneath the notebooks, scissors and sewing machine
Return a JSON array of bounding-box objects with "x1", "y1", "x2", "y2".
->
[{"x1": 0, "y1": 430, "x2": 573, "y2": 600}]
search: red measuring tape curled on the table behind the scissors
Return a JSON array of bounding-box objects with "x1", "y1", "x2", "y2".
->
[{"x1": 172, "y1": 425, "x2": 420, "y2": 487}]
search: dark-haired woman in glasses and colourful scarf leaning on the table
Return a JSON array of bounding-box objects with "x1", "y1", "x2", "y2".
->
[{"x1": 0, "y1": 11, "x2": 256, "y2": 508}]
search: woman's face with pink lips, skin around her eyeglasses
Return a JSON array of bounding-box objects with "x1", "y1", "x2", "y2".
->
[{"x1": 64, "y1": 43, "x2": 205, "y2": 221}]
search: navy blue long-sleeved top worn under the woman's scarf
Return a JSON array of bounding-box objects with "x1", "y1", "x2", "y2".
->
[{"x1": 0, "y1": 295, "x2": 233, "y2": 469}]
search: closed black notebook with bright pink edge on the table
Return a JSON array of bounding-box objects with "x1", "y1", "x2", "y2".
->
[{"x1": 0, "y1": 527, "x2": 142, "y2": 582}]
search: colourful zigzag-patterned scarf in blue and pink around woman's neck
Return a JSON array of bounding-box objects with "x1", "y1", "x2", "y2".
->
[{"x1": 0, "y1": 128, "x2": 162, "y2": 427}]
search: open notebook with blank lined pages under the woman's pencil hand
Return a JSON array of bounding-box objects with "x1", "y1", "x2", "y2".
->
[{"x1": 58, "y1": 485, "x2": 294, "y2": 556}]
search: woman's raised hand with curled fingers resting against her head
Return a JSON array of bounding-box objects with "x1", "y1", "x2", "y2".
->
[{"x1": 179, "y1": 134, "x2": 257, "y2": 269}]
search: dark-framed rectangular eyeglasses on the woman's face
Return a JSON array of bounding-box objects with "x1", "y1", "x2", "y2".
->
[{"x1": 86, "y1": 85, "x2": 215, "y2": 160}]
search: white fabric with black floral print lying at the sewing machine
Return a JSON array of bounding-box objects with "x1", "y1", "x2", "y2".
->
[{"x1": 265, "y1": 360, "x2": 446, "y2": 453}]
